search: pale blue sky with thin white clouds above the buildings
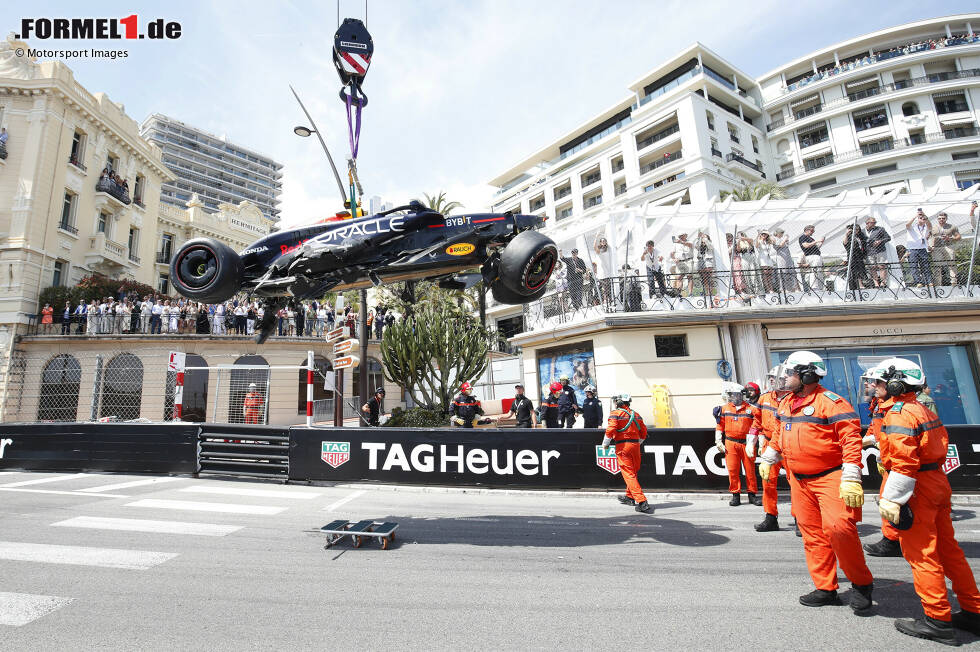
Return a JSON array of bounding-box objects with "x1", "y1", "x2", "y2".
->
[{"x1": 0, "y1": 0, "x2": 976, "y2": 225}]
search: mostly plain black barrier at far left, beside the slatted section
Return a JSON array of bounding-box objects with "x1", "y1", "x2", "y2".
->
[{"x1": 0, "y1": 423, "x2": 198, "y2": 473}]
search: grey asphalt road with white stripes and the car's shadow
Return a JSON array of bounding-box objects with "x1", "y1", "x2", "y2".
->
[{"x1": 0, "y1": 473, "x2": 980, "y2": 651}]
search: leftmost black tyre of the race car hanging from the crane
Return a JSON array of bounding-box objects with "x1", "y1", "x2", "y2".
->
[{"x1": 170, "y1": 238, "x2": 243, "y2": 303}]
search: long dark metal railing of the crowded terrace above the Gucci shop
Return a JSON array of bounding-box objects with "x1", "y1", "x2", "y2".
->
[{"x1": 524, "y1": 260, "x2": 980, "y2": 331}]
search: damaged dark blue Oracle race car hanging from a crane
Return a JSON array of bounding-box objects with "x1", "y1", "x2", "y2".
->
[{"x1": 170, "y1": 201, "x2": 558, "y2": 342}]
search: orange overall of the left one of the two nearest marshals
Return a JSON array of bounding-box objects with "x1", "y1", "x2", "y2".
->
[{"x1": 769, "y1": 385, "x2": 872, "y2": 591}]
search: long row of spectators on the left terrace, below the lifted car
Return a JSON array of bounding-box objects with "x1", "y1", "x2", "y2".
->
[{"x1": 35, "y1": 293, "x2": 397, "y2": 339}]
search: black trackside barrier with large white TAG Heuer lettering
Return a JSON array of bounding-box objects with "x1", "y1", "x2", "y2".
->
[{"x1": 289, "y1": 426, "x2": 980, "y2": 492}]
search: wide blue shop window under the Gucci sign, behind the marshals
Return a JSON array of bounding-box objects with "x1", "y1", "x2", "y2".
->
[{"x1": 772, "y1": 346, "x2": 980, "y2": 425}]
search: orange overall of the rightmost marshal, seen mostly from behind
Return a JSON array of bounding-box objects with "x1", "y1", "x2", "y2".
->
[{"x1": 878, "y1": 392, "x2": 980, "y2": 622}]
